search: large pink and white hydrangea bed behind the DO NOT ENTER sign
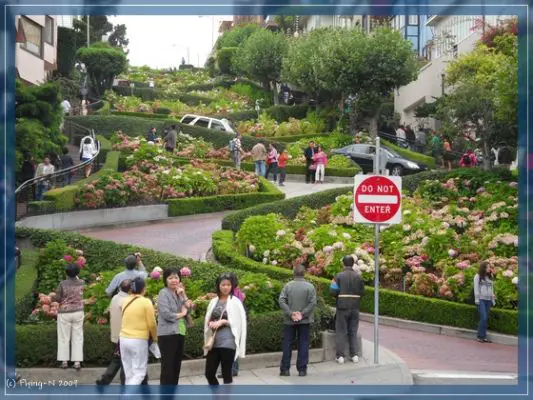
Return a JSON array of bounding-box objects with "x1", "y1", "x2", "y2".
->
[{"x1": 231, "y1": 172, "x2": 518, "y2": 309}]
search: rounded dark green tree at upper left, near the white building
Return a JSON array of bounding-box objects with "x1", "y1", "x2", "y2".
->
[{"x1": 77, "y1": 42, "x2": 127, "y2": 97}]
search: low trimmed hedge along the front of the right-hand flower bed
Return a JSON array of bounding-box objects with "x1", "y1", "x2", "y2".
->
[{"x1": 213, "y1": 231, "x2": 518, "y2": 335}]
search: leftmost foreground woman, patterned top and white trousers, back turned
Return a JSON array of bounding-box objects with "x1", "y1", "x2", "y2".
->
[{"x1": 52, "y1": 264, "x2": 85, "y2": 370}]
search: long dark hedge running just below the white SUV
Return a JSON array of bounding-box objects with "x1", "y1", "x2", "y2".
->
[{"x1": 67, "y1": 115, "x2": 285, "y2": 150}]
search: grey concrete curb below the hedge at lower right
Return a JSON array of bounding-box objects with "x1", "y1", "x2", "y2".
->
[{"x1": 360, "y1": 313, "x2": 518, "y2": 347}]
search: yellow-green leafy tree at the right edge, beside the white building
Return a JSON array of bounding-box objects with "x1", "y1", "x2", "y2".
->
[{"x1": 437, "y1": 33, "x2": 518, "y2": 169}]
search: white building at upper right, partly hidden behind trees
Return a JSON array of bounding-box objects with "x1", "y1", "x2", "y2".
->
[{"x1": 394, "y1": 15, "x2": 508, "y2": 128}]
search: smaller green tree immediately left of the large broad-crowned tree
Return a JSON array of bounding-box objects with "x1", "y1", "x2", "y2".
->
[{"x1": 232, "y1": 29, "x2": 287, "y2": 103}]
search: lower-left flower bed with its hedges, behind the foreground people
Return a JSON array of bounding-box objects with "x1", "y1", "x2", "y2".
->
[{"x1": 16, "y1": 228, "x2": 331, "y2": 367}]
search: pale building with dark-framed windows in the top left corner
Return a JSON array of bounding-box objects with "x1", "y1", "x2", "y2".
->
[{"x1": 15, "y1": 15, "x2": 57, "y2": 85}]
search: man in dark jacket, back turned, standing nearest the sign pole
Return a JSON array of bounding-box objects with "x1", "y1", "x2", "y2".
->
[{"x1": 330, "y1": 256, "x2": 365, "y2": 364}]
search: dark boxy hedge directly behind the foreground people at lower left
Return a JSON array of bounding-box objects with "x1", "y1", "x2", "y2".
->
[{"x1": 15, "y1": 307, "x2": 332, "y2": 368}]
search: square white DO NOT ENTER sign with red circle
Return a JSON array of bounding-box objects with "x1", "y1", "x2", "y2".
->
[{"x1": 353, "y1": 175, "x2": 402, "y2": 224}]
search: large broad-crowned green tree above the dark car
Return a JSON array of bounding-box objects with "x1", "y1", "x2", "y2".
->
[{"x1": 283, "y1": 28, "x2": 418, "y2": 137}]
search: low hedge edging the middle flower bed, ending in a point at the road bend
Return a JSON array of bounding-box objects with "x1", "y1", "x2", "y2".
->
[{"x1": 166, "y1": 178, "x2": 285, "y2": 217}]
